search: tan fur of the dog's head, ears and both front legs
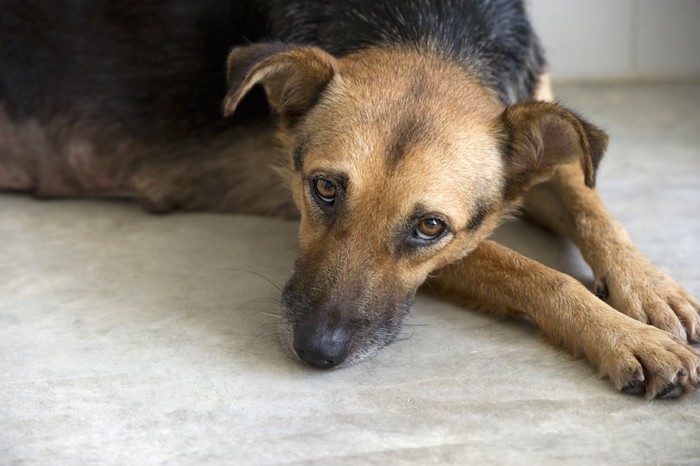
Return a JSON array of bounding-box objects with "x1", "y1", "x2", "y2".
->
[{"x1": 225, "y1": 48, "x2": 700, "y2": 398}]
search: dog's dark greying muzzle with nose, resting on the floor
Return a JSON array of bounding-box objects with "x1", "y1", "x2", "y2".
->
[{"x1": 280, "y1": 255, "x2": 415, "y2": 369}]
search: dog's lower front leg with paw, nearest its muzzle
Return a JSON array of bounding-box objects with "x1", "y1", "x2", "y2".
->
[{"x1": 428, "y1": 241, "x2": 700, "y2": 398}]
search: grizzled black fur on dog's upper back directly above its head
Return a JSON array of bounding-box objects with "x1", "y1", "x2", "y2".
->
[{"x1": 270, "y1": 0, "x2": 544, "y2": 104}]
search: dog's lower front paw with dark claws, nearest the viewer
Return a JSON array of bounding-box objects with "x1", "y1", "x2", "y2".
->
[{"x1": 598, "y1": 322, "x2": 700, "y2": 399}]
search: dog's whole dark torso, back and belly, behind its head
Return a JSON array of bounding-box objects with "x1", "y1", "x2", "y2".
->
[{"x1": 0, "y1": 0, "x2": 543, "y2": 209}]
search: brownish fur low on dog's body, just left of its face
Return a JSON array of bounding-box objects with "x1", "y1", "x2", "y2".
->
[{"x1": 128, "y1": 126, "x2": 298, "y2": 218}]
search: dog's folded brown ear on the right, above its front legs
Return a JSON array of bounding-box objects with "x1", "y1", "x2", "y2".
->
[{"x1": 500, "y1": 101, "x2": 608, "y2": 194}]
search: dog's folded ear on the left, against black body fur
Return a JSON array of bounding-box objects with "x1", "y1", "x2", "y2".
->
[{"x1": 223, "y1": 43, "x2": 339, "y2": 121}]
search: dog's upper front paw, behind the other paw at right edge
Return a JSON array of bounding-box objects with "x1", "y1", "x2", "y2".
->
[{"x1": 594, "y1": 253, "x2": 700, "y2": 342}]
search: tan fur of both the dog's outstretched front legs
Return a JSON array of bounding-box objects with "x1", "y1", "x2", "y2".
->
[{"x1": 432, "y1": 74, "x2": 700, "y2": 398}]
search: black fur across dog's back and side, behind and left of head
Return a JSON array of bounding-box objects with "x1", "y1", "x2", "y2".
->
[{"x1": 0, "y1": 0, "x2": 543, "y2": 138}]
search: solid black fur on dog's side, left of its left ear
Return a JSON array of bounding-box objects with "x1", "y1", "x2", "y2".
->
[{"x1": 0, "y1": 0, "x2": 267, "y2": 138}]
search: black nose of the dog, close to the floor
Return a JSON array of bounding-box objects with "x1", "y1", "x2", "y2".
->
[{"x1": 294, "y1": 324, "x2": 350, "y2": 369}]
